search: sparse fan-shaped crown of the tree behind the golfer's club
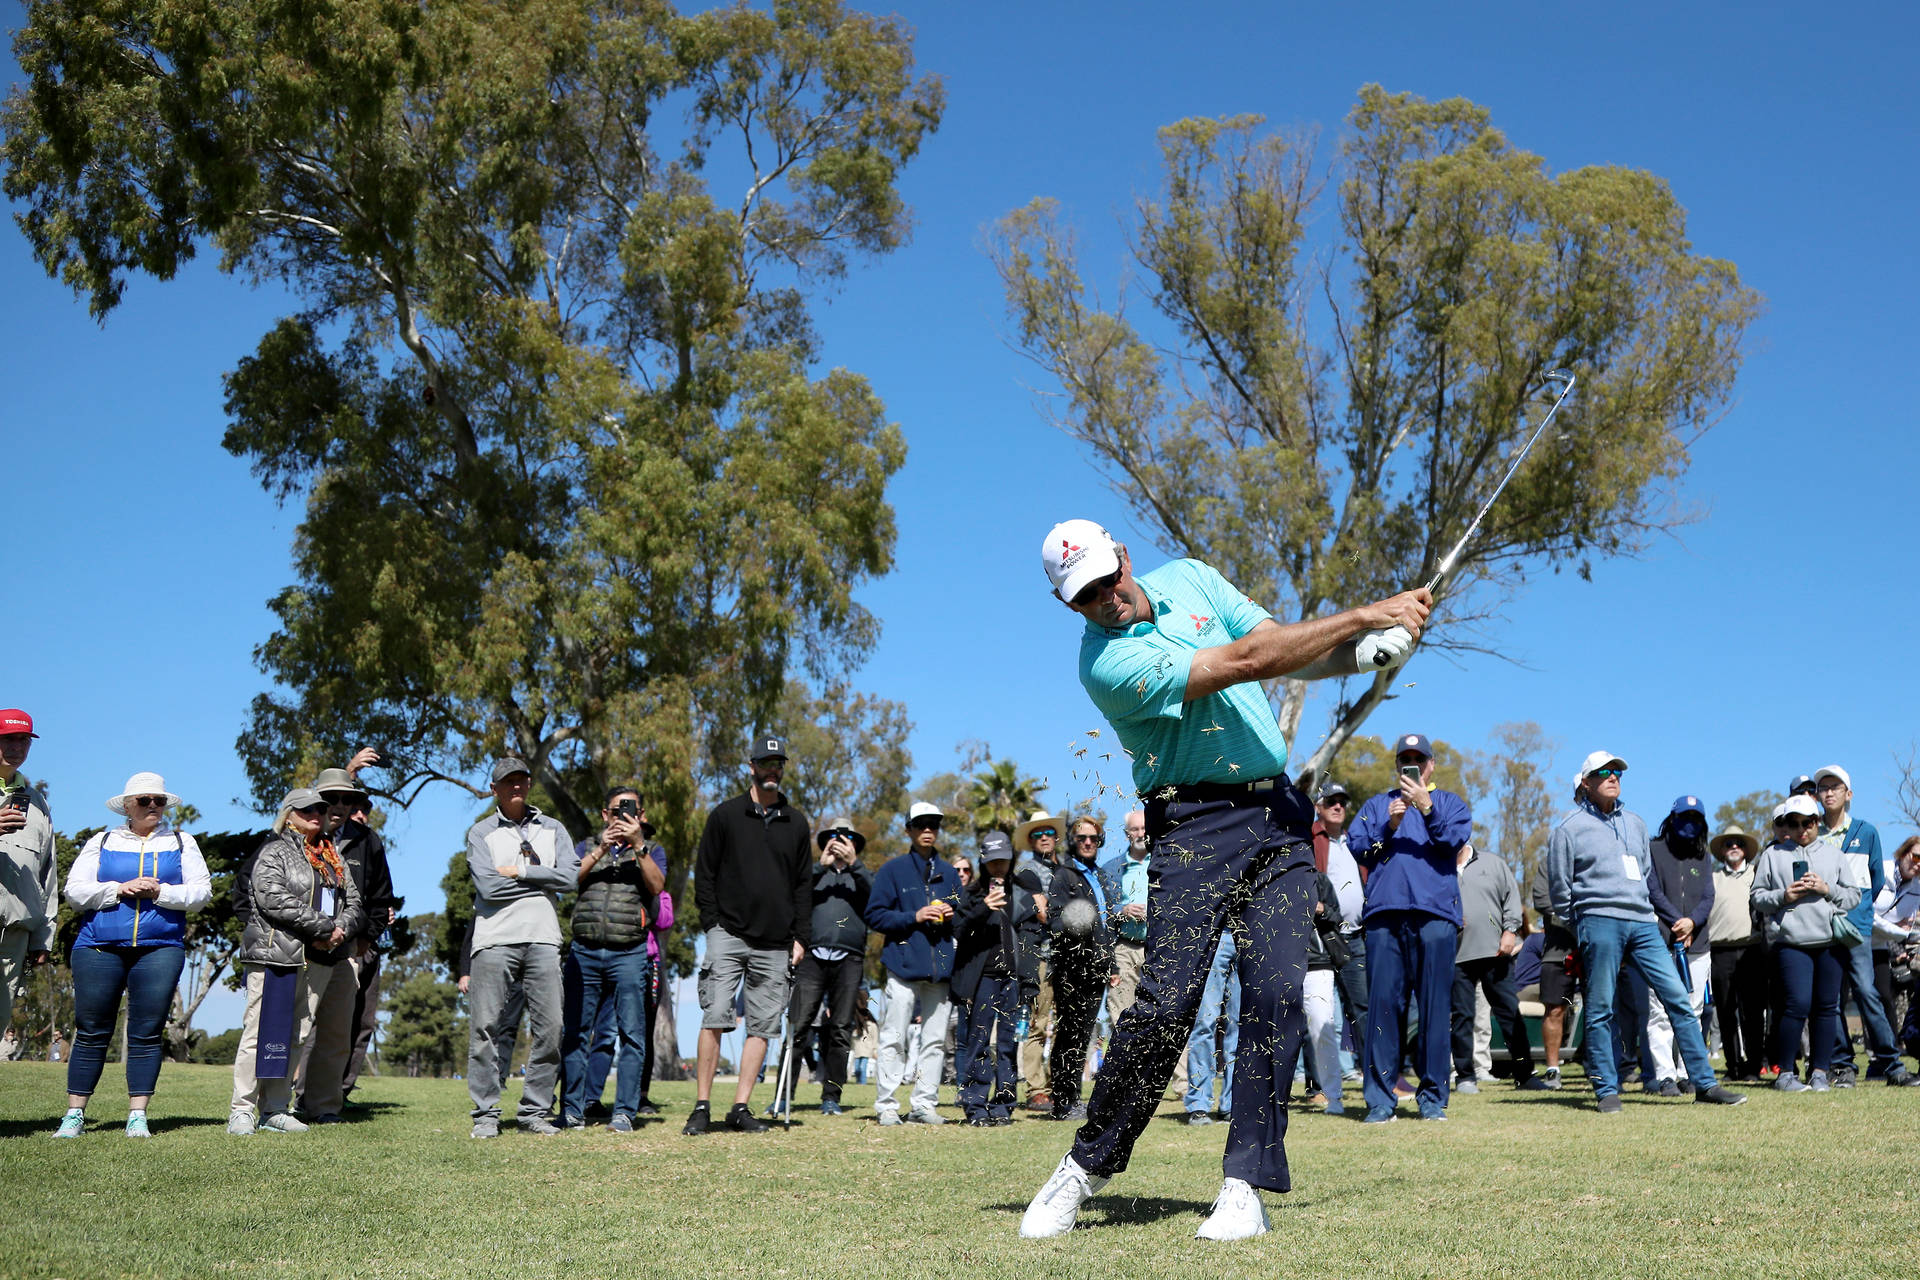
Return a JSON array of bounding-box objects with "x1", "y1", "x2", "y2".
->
[{"x1": 989, "y1": 86, "x2": 1761, "y2": 773}]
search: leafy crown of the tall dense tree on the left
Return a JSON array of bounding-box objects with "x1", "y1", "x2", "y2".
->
[{"x1": 0, "y1": 0, "x2": 943, "y2": 932}]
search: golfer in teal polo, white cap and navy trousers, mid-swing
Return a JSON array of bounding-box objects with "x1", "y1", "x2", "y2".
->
[{"x1": 1020, "y1": 520, "x2": 1432, "y2": 1240}]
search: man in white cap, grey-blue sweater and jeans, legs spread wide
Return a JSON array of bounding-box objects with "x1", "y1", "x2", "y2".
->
[{"x1": 1548, "y1": 750, "x2": 1747, "y2": 1115}]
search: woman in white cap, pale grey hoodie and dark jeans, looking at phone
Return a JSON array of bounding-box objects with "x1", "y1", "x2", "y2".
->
[{"x1": 1751, "y1": 796, "x2": 1860, "y2": 1094}]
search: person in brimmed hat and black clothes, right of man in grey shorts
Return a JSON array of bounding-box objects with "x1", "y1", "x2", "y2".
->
[{"x1": 768, "y1": 818, "x2": 874, "y2": 1115}]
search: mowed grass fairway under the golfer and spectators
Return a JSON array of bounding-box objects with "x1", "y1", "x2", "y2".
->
[{"x1": 0, "y1": 1063, "x2": 1920, "y2": 1280}]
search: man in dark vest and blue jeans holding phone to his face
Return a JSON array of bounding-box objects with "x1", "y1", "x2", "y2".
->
[{"x1": 561, "y1": 787, "x2": 666, "y2": 1134}]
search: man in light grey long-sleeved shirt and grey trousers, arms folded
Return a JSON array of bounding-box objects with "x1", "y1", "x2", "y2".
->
[{"x1": 467, "y1": 756, "x2": 580, "y2": 1138}]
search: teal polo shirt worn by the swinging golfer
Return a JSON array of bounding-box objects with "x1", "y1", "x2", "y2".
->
[{"x1": 1079, "y1": 560, "x2": 1286, "y2": 798}]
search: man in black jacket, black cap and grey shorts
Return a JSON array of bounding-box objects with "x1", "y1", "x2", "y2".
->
[{"x1": 684, "y1": 735, "x2": 814, "y2": 1134}]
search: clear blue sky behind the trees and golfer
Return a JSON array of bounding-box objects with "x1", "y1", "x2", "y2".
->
[{"x1": 0, "y1": 4, "x2": 1920, "y2": 1029}]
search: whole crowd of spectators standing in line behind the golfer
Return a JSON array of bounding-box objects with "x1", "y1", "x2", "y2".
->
[{"x1": 0, "y1": 710, "x2": 1920, "y2": 1138}]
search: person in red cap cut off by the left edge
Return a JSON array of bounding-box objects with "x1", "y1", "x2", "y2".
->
[{"x1": 0, "y1": 706, "x2": 60, "y2": 1032}]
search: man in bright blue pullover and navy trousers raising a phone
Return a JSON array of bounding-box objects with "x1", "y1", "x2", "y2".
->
[{"x1": 1348, "y1": 733, "x2": 1473, "y2": 1125}]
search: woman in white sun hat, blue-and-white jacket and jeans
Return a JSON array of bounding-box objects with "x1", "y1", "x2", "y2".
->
[{"x1": 56, "y1": 773, "x2": 213, "y2": 1138}]
